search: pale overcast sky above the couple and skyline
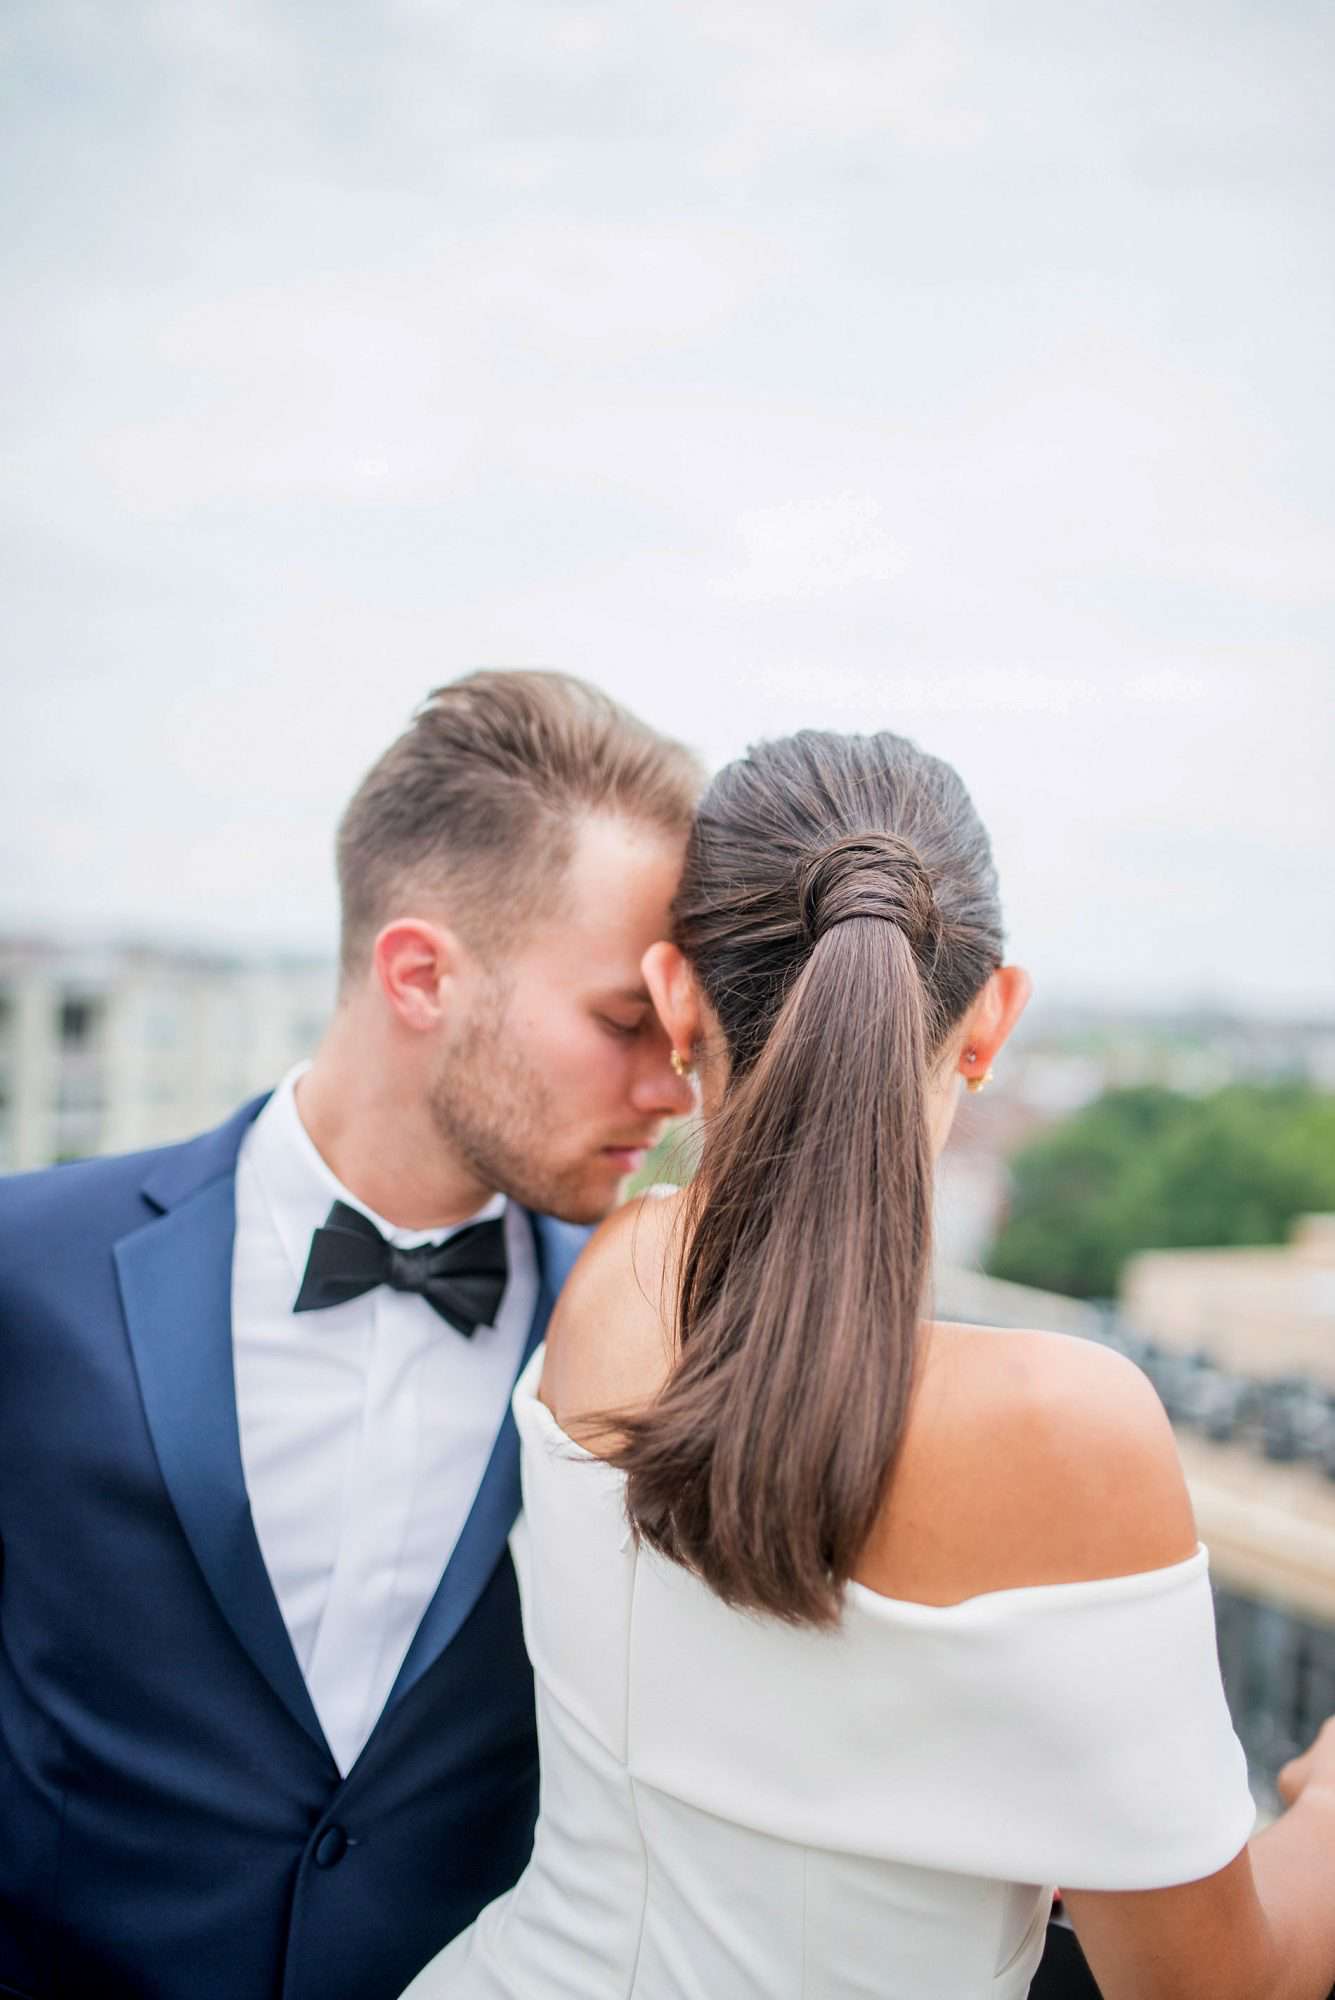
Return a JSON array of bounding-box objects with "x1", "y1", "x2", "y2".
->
[{"x1": 0, "y1": 0, "x2": 1335, "y2": 1012}]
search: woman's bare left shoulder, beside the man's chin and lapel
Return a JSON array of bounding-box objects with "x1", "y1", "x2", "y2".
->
[{"x1": 540, "y1": 1190, "x2": 681, "y2": 1430}]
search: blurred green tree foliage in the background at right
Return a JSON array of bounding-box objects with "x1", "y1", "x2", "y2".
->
[{"x1": 987, "y1": 1084, "x2": 1335, "y2": 1298}]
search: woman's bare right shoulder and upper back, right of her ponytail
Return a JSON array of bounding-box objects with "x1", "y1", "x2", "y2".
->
[{"x1": 857, "y1": 1324, "x2": 1197, "y2": 1604}]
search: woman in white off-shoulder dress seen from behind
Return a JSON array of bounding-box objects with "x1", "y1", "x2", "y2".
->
[{"x1": 410, "y1": 732, "x2": 1335, "y2": 2000}]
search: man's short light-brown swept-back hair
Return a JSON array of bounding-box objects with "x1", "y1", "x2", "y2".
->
[{"x1": 338, "y1": 670, "x2": 703, "y2": 980}]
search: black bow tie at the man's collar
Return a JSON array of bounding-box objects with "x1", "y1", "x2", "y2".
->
[{"x1": 292, "y1": 1202, "x2": 506, "y2": 1334}]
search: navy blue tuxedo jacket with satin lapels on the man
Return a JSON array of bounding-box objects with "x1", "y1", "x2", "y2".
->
[{"x1": 0, "y1": 1100, "x2": 586, "y2": 2000}]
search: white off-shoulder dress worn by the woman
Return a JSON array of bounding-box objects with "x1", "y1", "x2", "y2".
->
[{"x1": 408, "y1": 1352, "x2": 1253, "y2": 2000}]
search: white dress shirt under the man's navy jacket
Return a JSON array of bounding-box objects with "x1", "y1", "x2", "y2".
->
[{"x1": 232, "y1": 1064, "x2": 538, "y2": 1772}]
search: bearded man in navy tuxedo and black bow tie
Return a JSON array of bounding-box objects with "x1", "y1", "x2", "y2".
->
[{"x1": 0, "y1": 674, "x2": 699, "y2": 2000}]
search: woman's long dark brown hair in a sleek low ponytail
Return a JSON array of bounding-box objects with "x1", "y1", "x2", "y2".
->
[{"x1": 616, "y1": 730, "x2": 1001, "y2": 1624}]
